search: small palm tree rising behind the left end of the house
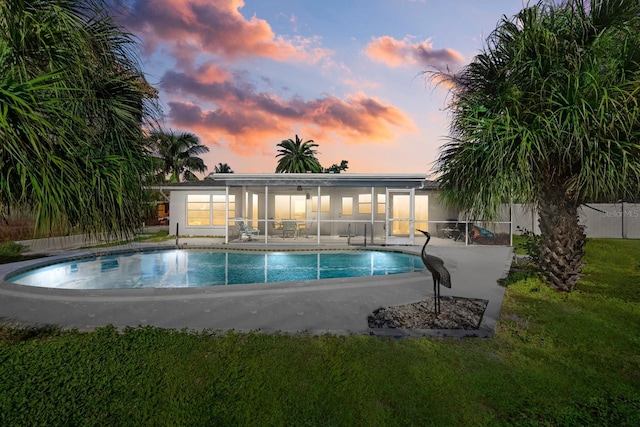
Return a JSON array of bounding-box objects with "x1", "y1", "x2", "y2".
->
[{"x1": 149, "y1": 130, "x2": 209, "y2": 182}]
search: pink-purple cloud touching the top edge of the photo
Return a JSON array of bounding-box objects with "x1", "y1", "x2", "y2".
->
[{"x1": 118, "y1": 0, "x2": 329, "y2": 62}]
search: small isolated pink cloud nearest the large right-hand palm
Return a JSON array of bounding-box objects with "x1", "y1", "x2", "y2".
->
[{"x1": 365, "y1": 36, "x2": 464, "y2": 68}]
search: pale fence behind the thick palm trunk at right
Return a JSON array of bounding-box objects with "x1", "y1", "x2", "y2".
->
[{"x1": 512, "y1": 202, "x2": 640, "y2": 239}]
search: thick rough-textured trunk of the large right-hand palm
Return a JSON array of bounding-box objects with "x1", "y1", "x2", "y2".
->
[{"x1": 538, "y1": 194, "x2": 586, "y2": 292}]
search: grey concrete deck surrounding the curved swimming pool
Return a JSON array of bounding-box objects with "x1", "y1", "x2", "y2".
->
[{"x1": 0, "y1": 238, "x2": 512, "y2": 337}]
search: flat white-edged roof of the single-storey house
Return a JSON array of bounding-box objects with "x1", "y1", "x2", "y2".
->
[{"x1": 155, "y1": 173, "x2": 437, "y2": 190}]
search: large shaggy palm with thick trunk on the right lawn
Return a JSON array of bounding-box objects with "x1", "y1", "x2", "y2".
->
[{"x1": 430, "y1": 0, "x2": 640, "y2": 291}]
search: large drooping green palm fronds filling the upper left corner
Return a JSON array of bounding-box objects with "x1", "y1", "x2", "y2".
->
[{"x1": 0, "y1": 0, "x2": 156, "y2": 239}]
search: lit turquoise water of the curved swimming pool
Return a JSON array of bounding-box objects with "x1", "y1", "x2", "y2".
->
[{"x1": 6, "y1": 249, "x2": 424, "y2": 289}]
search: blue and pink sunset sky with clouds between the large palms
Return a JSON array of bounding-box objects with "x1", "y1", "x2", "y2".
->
[{"x1": 115, "y1": 0, "x2": 523, "y2": 175}]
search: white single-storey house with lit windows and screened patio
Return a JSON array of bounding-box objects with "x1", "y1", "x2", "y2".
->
[{"x1": 161, "y1": 173, "x2": 458, "y2": 244}]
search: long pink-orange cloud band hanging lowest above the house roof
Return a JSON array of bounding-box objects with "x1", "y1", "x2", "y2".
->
[{"x1": 161, "y1": 67, "x2": 416, "y2": 155}]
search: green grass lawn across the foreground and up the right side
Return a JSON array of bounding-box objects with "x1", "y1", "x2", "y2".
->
[{"x1": 0, "y1": 239, "x2": 640, "y2": 426}]
